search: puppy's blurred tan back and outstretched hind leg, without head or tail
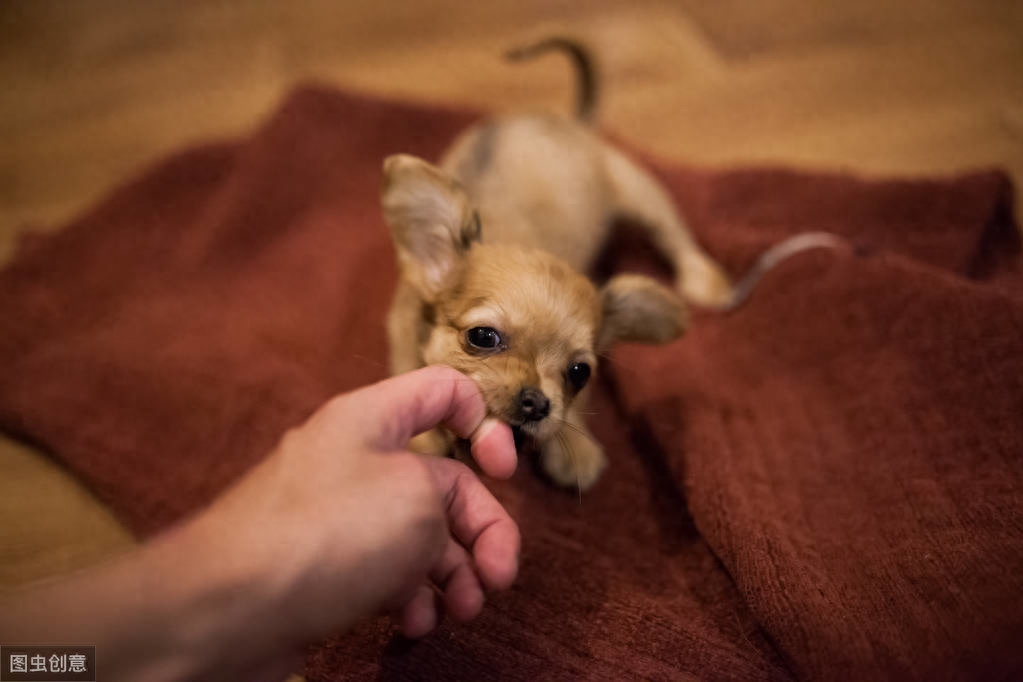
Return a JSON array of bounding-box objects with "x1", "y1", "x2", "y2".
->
[{"x1": 441, "y1": 113, "x2": 731, "y2": 307}]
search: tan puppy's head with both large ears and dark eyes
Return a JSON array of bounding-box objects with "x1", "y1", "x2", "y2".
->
[{"x1": 383, "y1": 155, "x2": 685, "y2": 443}]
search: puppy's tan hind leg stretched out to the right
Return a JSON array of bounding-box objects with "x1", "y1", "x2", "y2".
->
[{"x1": 605, "y1": 146, "x2": 732, "y2": 309}]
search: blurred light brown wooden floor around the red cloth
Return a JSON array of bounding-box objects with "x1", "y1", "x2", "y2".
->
[{"x1": 0, "y1": 0, "x2": 1023, "y2": 585}]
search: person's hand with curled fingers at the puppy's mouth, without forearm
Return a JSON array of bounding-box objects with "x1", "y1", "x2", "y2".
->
[{"x1": 182, "y1": 367, "x2": 520, "y2": 662}]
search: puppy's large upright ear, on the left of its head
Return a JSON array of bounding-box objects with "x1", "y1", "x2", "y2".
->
[{"x1": 381, "y1": 154, "x2": 480, "y2": 301}]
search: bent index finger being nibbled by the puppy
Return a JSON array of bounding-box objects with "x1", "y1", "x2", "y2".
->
[{"x1": 351, "y1": 365, "x2": 518, "y2": 479}]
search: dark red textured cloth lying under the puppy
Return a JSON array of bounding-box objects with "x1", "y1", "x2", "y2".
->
[{"x1": 0, "y1": 88, "x2": 1023, "y2": 680}]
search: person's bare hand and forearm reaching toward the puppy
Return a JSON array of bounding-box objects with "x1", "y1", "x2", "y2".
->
[{"x1": 0, "y1": 366, "x2": 520, "y2": 680}]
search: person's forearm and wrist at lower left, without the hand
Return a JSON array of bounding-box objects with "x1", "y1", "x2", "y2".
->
[{"x1": 0, "y1": 522, "x2": 296, "y2": 681}]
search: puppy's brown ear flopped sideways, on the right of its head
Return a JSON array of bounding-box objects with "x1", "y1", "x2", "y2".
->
[{"x1": 597, "y1": 275, "x2": 688, "y2": 350}]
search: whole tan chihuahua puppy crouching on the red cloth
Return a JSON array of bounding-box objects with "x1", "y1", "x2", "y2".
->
[{"x1": 382, "y1": 39, "x2": 838, "y2": 491}]
